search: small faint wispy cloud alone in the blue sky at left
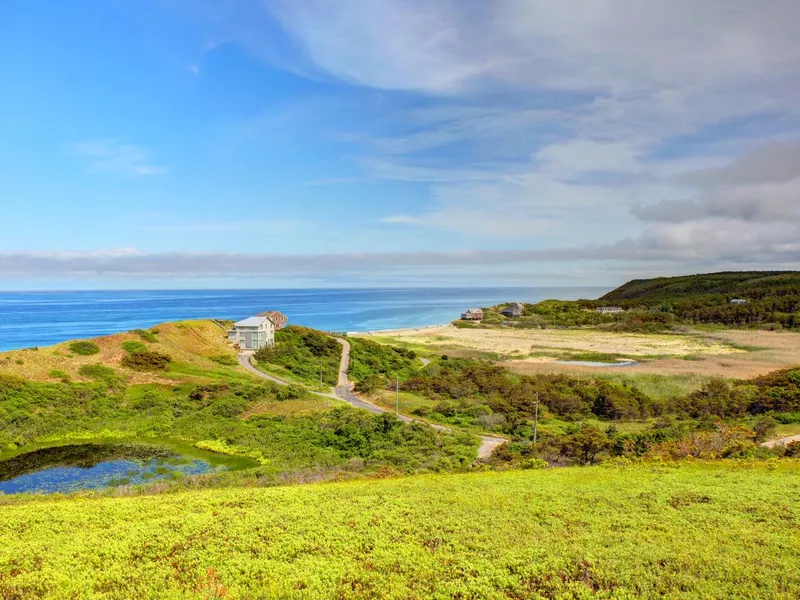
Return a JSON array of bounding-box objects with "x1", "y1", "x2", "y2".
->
[{"x1": 72, "y1": 139, "x2": 166, "y2": 177}]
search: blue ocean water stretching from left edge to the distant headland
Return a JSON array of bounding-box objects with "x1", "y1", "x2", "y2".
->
[{"x1": 0, "y1": 287, "x2": 608, "y2": 351}]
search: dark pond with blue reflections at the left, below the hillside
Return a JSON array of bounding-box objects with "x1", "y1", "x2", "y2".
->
[{"x1": 0, "y1": 441, "x2": 258, "y2": 494}]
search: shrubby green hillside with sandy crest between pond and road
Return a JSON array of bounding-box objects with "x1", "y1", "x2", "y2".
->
[{"x1": 0, "y1": 320, "x2": 478, "y2": 486}]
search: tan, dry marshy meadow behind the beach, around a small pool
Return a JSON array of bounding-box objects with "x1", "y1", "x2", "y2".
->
[{"x1": 370, "y1": 325, "x2": 800, "y2": 382}]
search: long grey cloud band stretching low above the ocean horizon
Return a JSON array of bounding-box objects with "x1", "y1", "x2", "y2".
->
[{"x1": 0, "y1": 227, "x2": 800, "y2": 280}]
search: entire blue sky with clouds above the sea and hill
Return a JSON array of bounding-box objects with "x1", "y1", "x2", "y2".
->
[{"x1": 0, "y1": 0, "x2": 800, "y2": 289}]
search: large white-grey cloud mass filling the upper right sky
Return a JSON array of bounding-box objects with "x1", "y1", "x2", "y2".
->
[{"x1": 184, "y1": 0, "x2": 800, "y2": 274}]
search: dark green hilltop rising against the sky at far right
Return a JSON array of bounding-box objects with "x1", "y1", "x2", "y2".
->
[{"x1": 600, "y1": 271, "x2": 800, "y2": 302}]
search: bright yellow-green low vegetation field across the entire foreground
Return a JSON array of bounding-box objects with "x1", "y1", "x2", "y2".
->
[{"x1": 0, "y1": 461, "x2": 800, "y2": 600}]
